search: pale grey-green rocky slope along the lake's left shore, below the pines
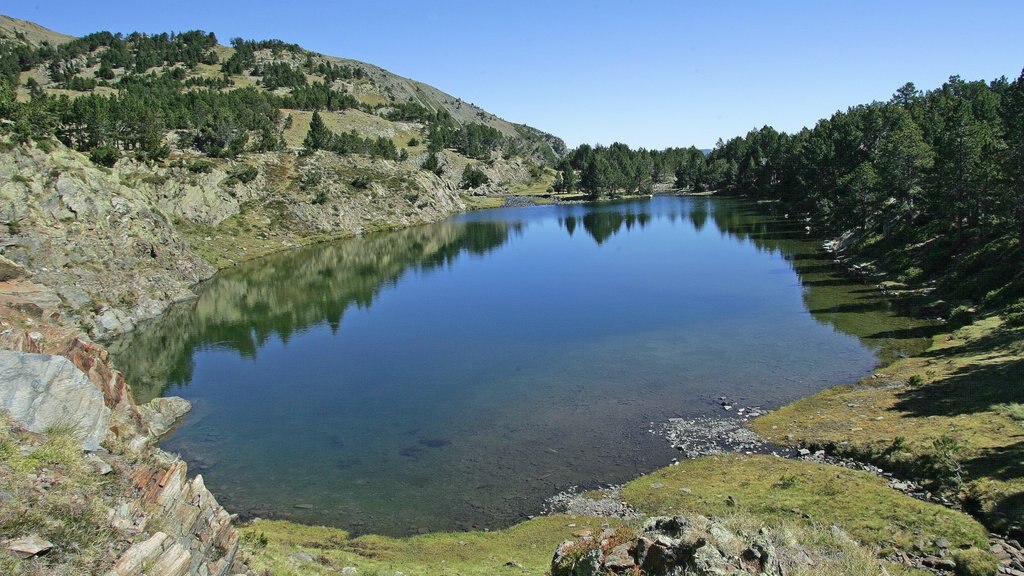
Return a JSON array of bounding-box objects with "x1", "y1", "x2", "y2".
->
[{"x1": 0, "y1": 137, "x2": 473, "y2": 337}]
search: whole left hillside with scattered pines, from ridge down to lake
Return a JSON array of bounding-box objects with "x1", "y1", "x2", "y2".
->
[{"x1": 0, "y1": 16, "x2": 565, "y2": 337}]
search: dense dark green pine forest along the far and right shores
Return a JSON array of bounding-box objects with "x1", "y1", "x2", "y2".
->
[{"x1": 555, "y1": 73, "x2": 1024, "y2": 300}]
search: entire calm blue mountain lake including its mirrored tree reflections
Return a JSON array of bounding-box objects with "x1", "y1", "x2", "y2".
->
[{"x1": 111, "y1": 197, "x2": 922, "y2": 534}]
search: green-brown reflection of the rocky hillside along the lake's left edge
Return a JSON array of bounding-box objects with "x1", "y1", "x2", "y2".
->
[{"x1": 110, "y1": 221, "x2": 523, "y2": 403}]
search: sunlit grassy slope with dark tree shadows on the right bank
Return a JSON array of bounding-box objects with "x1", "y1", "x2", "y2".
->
[{"x1": 752, "y1": 317, "x2": 1024, "y2": 530}]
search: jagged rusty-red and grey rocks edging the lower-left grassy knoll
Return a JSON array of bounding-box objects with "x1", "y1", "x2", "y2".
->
[{"x1": 0, "y1": 307, "x2": 248, "y2": 576}]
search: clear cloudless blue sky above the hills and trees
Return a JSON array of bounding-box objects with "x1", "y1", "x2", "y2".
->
[{"x1": 0, "y1": 0, "x2": 1024, "y2": 149}]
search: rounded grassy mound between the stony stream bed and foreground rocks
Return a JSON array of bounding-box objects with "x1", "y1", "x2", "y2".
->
[{"x1": 623, "y1": 455, "x2": 987, "y2": 553}]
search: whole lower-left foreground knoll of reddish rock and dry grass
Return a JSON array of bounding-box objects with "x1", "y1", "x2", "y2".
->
[{"x1": 0, "y1": 280, "x2": 247, "y2": 576}]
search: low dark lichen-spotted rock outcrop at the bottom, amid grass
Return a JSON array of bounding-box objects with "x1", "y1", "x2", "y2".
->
[{"x1": 551, "y1": 517, "x2": 783, "y2": 576}]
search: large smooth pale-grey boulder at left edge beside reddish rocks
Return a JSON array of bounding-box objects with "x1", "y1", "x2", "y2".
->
[{"x1": 0, "y1": 352, "x2": 111, "y2": 450}]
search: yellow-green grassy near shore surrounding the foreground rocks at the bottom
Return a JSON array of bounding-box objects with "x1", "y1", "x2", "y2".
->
[{"x1": 242, "y1": 455, "x2": 994, "y2": 576}]
